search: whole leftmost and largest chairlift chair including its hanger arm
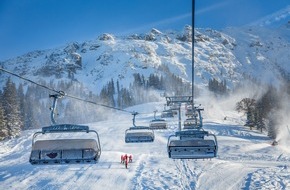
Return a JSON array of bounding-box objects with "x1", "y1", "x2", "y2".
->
[{"x1": 29, "y1": 92, "x2": 101, "y2": 165}]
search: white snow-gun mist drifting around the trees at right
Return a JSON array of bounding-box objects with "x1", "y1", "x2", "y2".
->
[{"x1": 196, "y1": 78, "x2": 290, "y2": 150}]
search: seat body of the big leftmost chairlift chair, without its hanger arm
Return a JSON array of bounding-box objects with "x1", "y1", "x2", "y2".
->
[{"x1": 29, "y1": 125, "x2": 101, "y2": 165}]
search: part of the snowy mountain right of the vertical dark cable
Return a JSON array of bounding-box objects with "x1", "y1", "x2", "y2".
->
[{"x1": 195, "y1": 23, "x2": 290, "y2": 85}]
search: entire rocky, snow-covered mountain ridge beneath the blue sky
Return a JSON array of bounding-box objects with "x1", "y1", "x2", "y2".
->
[{"x1": 0, "y1": 22, "x2": 290, "y2": 93}]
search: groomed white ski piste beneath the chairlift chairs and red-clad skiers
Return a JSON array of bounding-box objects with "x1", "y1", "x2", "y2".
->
[{"x1": 0, "y1": 102, "x2": 290, "y2": 190}]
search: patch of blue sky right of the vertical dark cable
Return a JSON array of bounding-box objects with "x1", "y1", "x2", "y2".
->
[{"x1": 195, "y1": 0, "x2": 290, "y2": 30}]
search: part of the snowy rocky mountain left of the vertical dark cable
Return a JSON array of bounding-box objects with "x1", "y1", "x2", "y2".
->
[{"x1": 1, "y1": 27, "x2": 191, "y2": 92}]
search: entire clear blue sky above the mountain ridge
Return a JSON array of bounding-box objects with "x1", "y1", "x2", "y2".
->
[{"x1": 0, "y1": 0, "x2": 289, "y2": 61}]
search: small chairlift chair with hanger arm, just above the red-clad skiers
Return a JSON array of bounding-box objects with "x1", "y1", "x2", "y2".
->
[{"x1": 125, "y1": 112, "x2": 155, "y2": 143}]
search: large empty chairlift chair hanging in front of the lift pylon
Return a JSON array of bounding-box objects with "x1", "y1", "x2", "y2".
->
[{"x1": 167, "y1": 130, "x2": 218, "y2": 159}]
